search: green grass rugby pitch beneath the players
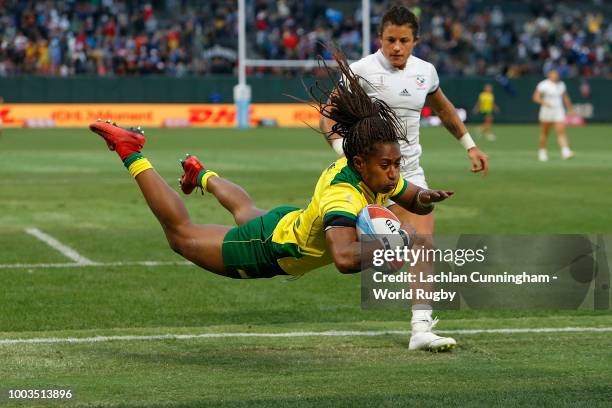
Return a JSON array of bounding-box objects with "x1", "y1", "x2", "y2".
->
[{"x1": 0, "y1": 125, "x2": 612, "y2": 407}]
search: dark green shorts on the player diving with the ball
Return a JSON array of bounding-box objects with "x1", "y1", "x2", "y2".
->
[{"x1": 221, "y1": 207, "x2": 299, "y2": 279}]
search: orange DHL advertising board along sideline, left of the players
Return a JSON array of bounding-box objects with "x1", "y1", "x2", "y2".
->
[{"x1": 0, "y1": 103, "x2": 319, "y2": 128}]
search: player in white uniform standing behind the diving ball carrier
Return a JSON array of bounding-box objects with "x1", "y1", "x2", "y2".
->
[{"x1": 321, "y1": 6, "x2": 489, "y2": 351}]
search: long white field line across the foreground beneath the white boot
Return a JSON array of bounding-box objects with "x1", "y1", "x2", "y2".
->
[{"x1": 0, "y1": 327, "x2": 612, "y2": 345}]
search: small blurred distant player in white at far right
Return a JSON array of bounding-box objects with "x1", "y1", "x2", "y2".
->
[{"x1": 533, "y1": 69, "x2": 574, "y2": 161}]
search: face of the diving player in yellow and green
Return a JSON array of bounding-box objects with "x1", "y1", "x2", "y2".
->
[{"x1": 353, "y1": 143, "x2": 402, "y2": 194}]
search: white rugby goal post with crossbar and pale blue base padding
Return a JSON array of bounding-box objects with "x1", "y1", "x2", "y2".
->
[{"x1": 234, "y1": 0, "x2": 370, "y2": 129}]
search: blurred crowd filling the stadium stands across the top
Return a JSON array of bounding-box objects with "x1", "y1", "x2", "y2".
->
[{"x1": 0, "y1": 0, "x2": 612, "y2": 77}]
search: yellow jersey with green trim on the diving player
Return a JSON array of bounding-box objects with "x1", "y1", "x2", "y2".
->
[{"x1": 272, "y1": 157, "x2": 408, "y2": 275}]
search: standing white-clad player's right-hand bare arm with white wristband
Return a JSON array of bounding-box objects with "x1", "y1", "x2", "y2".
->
[{"x1": 426, "y1": 88, "x2": 489, "y2": 176}]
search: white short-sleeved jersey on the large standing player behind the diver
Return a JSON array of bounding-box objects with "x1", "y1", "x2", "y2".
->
[{"x1": 351, "y1": 50, "x2": 440, "y2": 171}]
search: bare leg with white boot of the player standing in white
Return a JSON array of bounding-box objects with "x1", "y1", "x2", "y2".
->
[{"x1": 389, "y1": 205, "x2": 456, "y2": 352}]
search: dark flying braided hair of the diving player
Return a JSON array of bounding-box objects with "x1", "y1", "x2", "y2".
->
[{"x1": 310, "y1": 51, "x2": 408, "y2": 166}]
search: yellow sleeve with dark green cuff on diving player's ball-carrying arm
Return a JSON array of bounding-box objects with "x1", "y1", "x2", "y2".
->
[{"x1": 320, "y1": 183, "x2": 363, "y2": 229}]
